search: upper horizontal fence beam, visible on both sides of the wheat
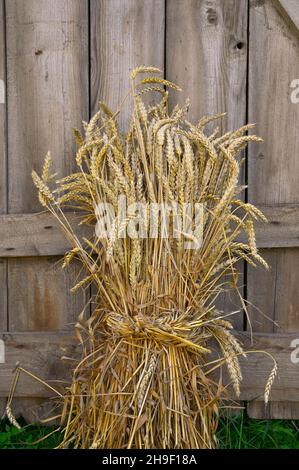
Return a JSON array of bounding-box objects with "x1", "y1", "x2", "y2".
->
[{"x1": 0, "y1": 204, "x2": 299, "y2": 258}]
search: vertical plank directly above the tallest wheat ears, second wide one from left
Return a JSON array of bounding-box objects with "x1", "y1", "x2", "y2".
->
[{"x1": 90, "y1": 0, "x2": 165, "y2": 123}]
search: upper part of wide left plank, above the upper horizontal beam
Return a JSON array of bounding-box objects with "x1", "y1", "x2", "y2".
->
[{"x1": 6, "y1": 0, "x2": 88, "y2": 213}]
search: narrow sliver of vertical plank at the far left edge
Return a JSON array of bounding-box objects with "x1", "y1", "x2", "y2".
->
[{"x1": 0, "y1": 0, "x2": 7, "y2": 330}]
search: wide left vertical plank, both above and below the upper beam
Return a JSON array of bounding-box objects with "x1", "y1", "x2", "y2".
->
[{"x1": 6, "y1": 0, "x2": 89, "y2": 331}]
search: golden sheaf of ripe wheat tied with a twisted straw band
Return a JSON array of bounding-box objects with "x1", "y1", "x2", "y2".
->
[{"x1": 33, "y1": 67, "x2": 274, "y2": 448}]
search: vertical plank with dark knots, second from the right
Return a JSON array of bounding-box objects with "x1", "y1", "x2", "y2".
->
[{"x1": 166, "y1": 0, "x2": 248, "y2": 329}]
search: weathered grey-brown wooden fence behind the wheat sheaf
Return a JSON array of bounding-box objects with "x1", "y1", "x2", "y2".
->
[{"x1": 0, "y1": 0, "x2": 299, "y2": 418}]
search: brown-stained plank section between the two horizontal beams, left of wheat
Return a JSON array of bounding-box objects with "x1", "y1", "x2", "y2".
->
[{"x1": 8, "y1": 258, "x2": 88, "y2": 331}]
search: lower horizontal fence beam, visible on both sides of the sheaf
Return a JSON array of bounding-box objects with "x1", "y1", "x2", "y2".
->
[{"x1": 0, "y1": 331, "x2": 299, "y2": 402}]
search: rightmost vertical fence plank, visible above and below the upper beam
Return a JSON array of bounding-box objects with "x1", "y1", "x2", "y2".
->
[{"x1": 248, "y1": 0, "x2": 299, "y2": 418}]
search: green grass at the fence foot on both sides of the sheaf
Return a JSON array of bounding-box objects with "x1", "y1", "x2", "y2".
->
[{"x1": 0, "y1": 413, "x2": 299, "y2": 449}]
